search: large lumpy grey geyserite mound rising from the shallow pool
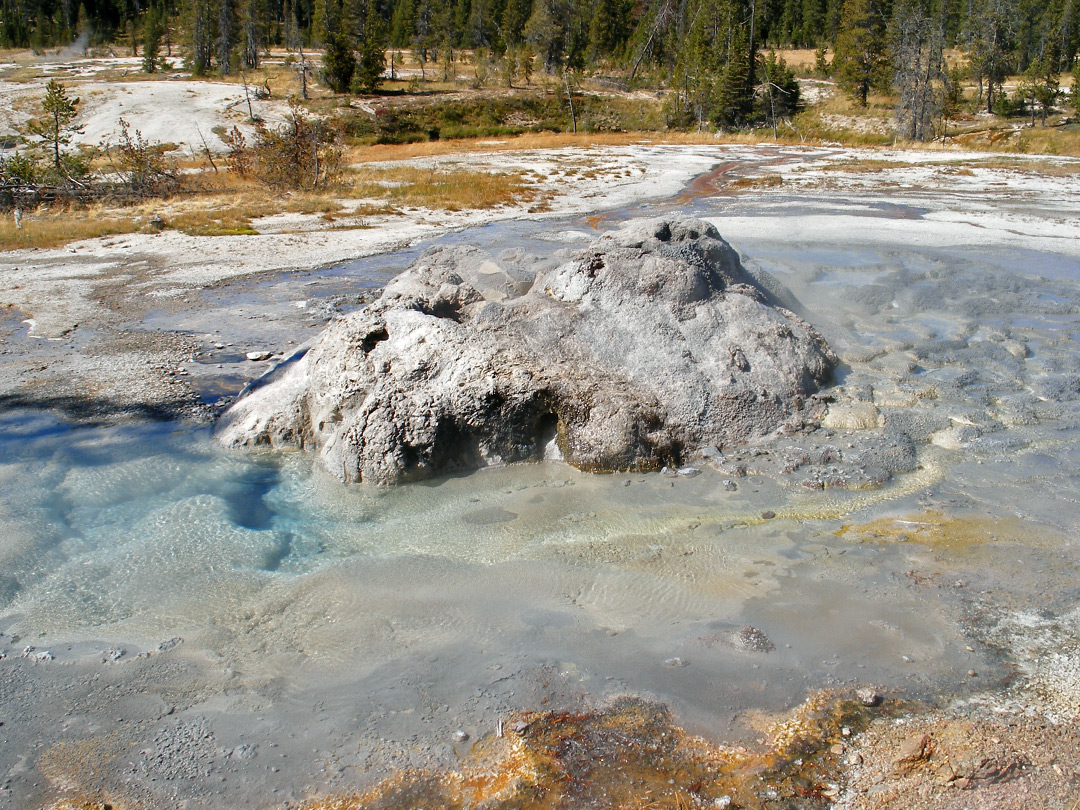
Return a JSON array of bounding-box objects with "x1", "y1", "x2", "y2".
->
[{"x1": 218, "y1": 219, "x2": 836, "y2": 484}]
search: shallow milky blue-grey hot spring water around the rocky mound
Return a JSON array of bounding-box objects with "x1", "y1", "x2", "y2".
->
[{"x1": 0, "y1": 162, "x2": 1080, "y2": 807}]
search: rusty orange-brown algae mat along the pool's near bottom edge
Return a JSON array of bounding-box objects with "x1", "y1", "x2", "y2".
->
[{"x1": 302, "y1": 692, "x2": 885, "y2": 810}]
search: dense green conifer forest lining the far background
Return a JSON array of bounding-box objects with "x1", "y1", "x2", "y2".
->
[{"x1": 0, "y1": 0, "x2": 1080, "y2": 139}]
